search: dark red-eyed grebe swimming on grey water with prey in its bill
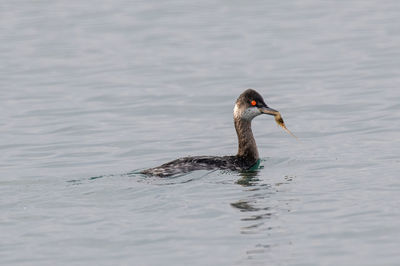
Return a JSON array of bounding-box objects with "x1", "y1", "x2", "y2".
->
[{"x1": 141, "y1": 89, "x2": 283, "y2": 177}]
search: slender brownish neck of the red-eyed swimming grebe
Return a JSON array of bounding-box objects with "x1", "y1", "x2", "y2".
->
[{"x1": 235, "y1": 119, "x2": 259, "y2": 165}]
